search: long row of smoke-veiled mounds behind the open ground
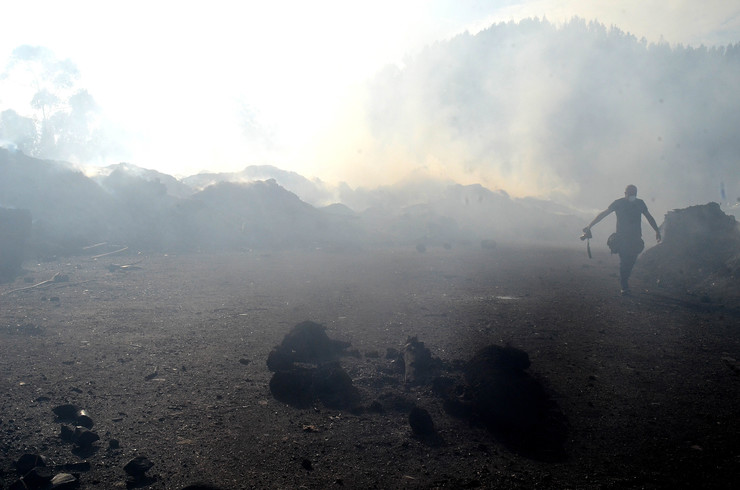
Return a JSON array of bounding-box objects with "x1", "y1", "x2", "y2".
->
[{"x1": 0, "y1": 149, "x2": 585, "y2": 256}]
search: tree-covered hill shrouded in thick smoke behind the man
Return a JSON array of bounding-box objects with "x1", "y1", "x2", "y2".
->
[{"x1": 322, "y1": 19, "x2": 740, "y2": 217}]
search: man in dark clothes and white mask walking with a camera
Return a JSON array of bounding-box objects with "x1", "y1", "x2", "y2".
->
[{"x1": 583, "y1": 184, "x2": 661, "y2": 295}]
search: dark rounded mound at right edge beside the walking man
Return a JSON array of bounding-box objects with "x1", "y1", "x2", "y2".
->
[{"x1": 635, "y1": 202, "x2": 740, "y2": 301}]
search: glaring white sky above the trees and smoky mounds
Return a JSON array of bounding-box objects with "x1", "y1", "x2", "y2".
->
[{"x1": 0, "y1": 0, "x2": 740, "y2": 185}]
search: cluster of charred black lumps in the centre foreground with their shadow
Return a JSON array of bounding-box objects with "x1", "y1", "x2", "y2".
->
[{"x1": 267, "y1": 321, "x2": 568, "y2": 461}]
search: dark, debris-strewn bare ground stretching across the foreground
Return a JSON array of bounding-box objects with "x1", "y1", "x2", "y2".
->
[{"x1": 0, "y1": 246, "x2": 740, "y2": 489}]
